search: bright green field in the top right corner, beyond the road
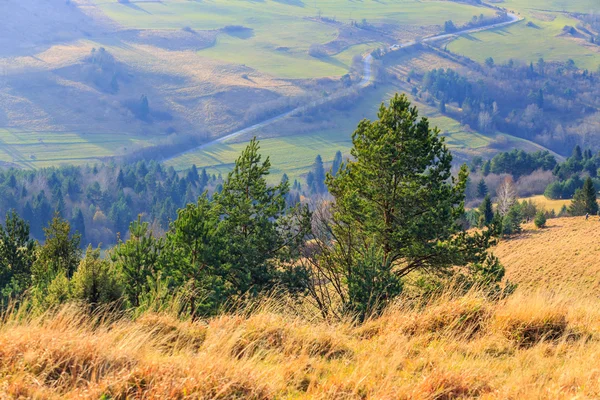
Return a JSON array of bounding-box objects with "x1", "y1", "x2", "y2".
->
[{"x1": 447, "y1": 0, "x2": 600, "y2": 70}]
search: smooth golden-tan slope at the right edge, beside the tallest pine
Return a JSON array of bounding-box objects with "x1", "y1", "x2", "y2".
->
[{"x1": 494, "y1": 217, "x2": 600, "y2": 292}]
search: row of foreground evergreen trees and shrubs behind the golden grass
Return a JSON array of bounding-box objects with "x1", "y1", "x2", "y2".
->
[{"x1": 0, "y1": 95, "x2": 504, "y2": 319}]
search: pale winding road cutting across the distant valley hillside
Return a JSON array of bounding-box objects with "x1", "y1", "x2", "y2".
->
[{"x1": 163, "y1": 12, "x2": 523, "y2": 162}]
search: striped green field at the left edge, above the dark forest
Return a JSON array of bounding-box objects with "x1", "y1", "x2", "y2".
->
[{"x1": 0, "y1": 128, "x2": 149, "y2": 168}]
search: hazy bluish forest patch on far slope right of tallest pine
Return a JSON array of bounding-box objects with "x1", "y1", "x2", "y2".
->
[{"x1": 413, "y1": 58, "x2": 600, "y2": 155}]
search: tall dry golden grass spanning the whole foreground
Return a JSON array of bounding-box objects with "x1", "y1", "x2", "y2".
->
[{"x1": 0, "y1": 286, "x2": 600, "y2": 399}]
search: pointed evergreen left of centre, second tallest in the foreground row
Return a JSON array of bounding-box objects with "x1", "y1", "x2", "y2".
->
[{"x1": 215, "y1": 138, "x2": 310, "y2": 304}]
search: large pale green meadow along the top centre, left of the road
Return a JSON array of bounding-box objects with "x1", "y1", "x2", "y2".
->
[{"x1": 97, "y1": 0, "x2": 493, "y2": 78}]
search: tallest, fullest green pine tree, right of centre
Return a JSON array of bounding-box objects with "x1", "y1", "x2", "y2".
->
[{"x1": 320, "y1": 95, "x2": 500, "y2": 316}]
